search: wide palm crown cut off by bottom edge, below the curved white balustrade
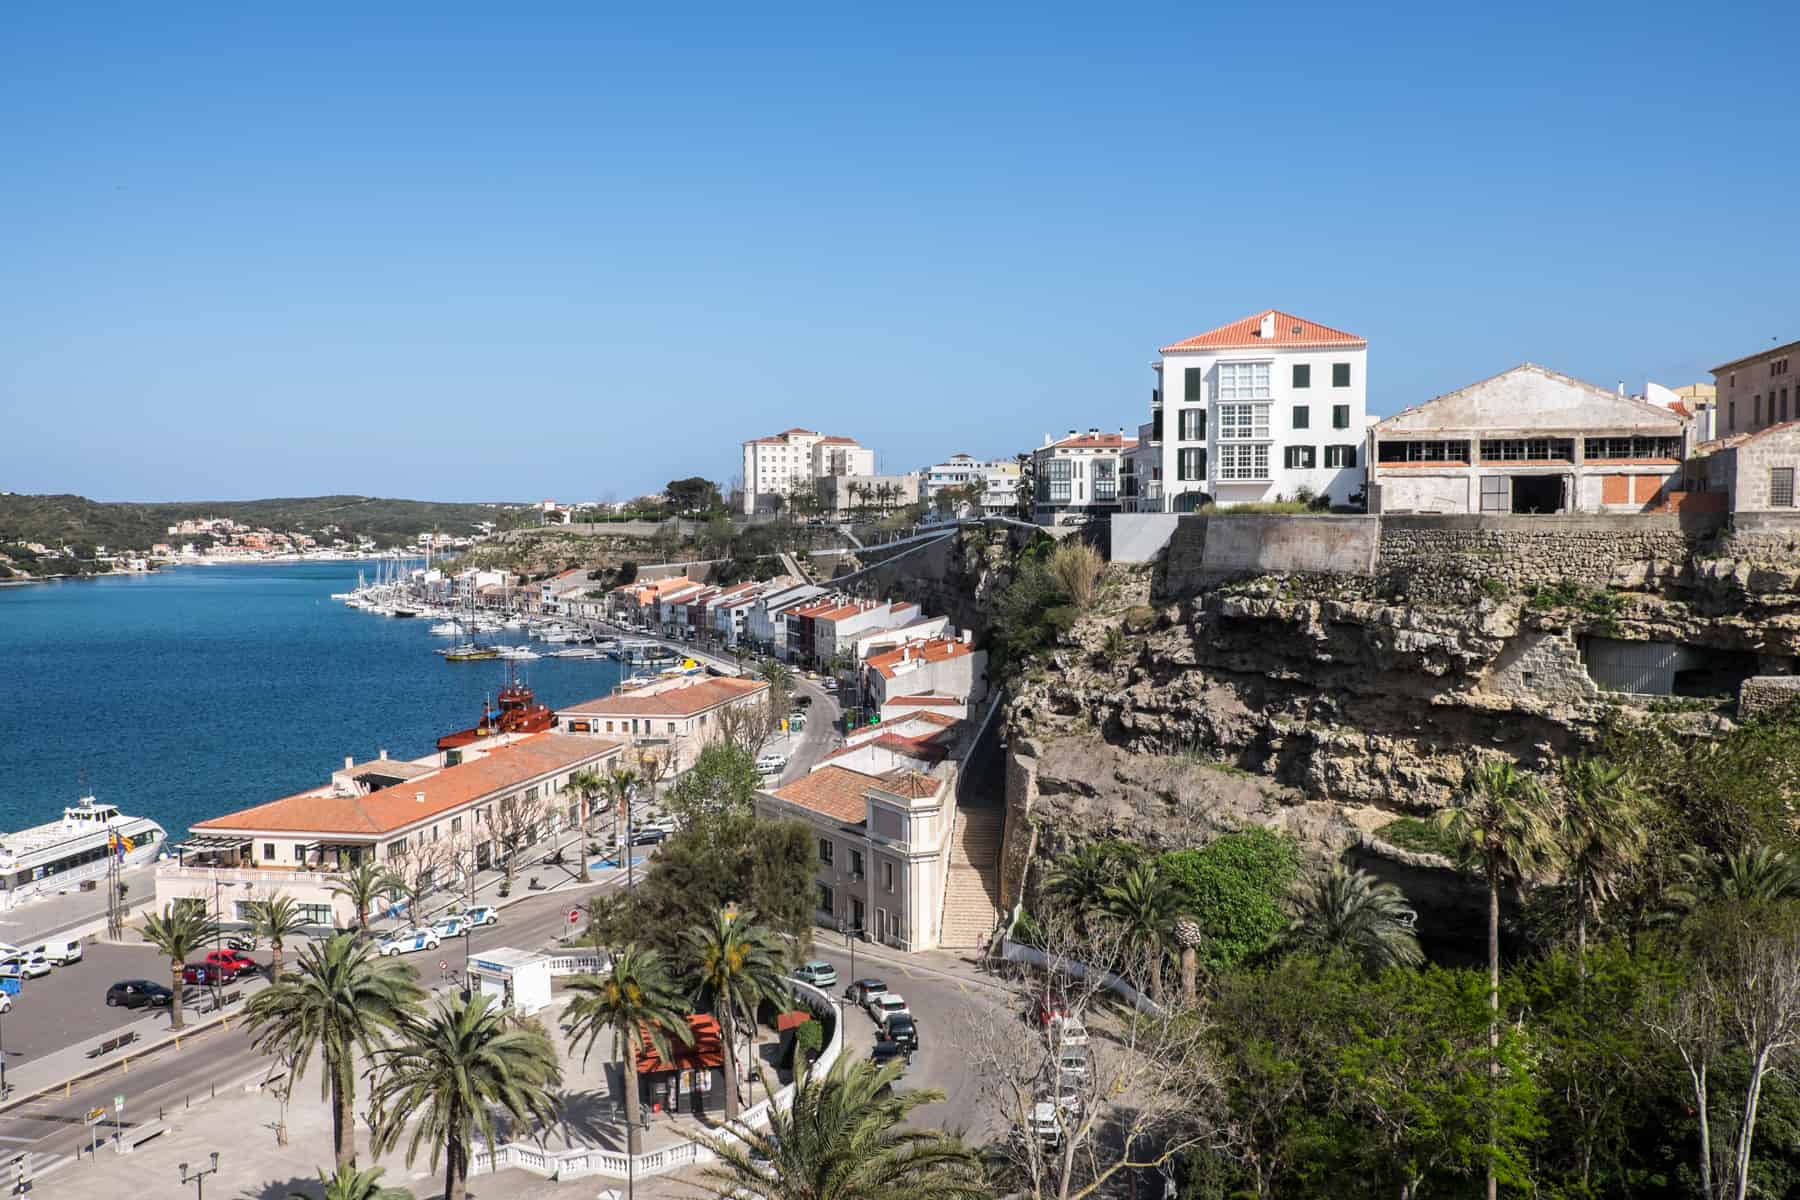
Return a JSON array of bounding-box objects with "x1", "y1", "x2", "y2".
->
[{"x1": 700, "y1": 1054, "x2": 994, "y2": 1200}]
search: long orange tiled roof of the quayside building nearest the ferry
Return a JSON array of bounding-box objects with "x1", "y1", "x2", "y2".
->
[{"x1": 193, "y1": 732, "x2": 623, "y2": 837}]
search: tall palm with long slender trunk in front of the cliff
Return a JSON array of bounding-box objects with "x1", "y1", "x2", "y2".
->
[{"x1": 1438, "y1": 757, "x2": 1557, "y2": 1200}]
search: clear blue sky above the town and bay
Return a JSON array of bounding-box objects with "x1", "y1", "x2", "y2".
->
[{"x1": 0, "y1": 4, "x2": 1800, "y2": 500}]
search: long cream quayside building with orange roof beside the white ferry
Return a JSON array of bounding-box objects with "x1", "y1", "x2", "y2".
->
[{"x1": 157, "y1": 732, "x2": 625, "y2": 927}]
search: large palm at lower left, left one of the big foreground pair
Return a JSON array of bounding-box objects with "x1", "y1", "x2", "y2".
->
[{"x1": 247, "y1": 934, "x2": 425, "y2": 1166}]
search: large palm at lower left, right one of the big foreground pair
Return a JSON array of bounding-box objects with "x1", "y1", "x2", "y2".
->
[{"x1": 371, "y1": 993, "x2": 562, "y2": 1200}]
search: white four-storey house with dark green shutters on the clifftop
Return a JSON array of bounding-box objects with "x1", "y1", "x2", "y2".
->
[{"x1": 1143, "y1": 308, "x2": 1368, "y2": 513}]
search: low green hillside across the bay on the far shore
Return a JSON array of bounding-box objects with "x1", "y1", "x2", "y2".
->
[{"x1": 0, "y1": 495, "x2": 522, "y2": 551}]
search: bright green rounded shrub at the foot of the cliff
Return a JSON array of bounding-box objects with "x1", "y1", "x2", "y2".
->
[{"x1": 1157, "y1": 828, "x2": 1300, "y2": 972}]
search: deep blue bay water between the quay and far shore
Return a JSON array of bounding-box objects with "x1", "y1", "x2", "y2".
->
[{"x1": 0, "y1": 563, "x2": 619, "y2": 837}]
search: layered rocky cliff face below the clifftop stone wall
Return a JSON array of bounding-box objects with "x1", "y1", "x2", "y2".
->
[{"x1": 1008, "y1": 536, "x2": 1800, "y2": 921}]
